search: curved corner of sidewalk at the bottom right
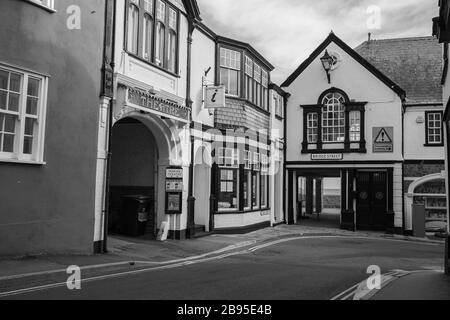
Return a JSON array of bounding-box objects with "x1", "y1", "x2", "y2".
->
[{"x1": 371, "y1": 271, "x2": 450, "y2": 300}]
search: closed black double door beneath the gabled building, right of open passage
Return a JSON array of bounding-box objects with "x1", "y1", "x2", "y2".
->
[{"x1": 356, "y1": 172, "x2": 388, "y2": 231}]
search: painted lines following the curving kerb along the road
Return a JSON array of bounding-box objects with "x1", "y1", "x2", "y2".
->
[{"x1": 0, "y1": 235, "x2": 442, "y2": 298}]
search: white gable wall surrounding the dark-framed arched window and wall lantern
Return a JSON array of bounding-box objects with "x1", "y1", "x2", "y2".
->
[{"x1": 283, "y1": 43, "x2": 402, "y2": 162}]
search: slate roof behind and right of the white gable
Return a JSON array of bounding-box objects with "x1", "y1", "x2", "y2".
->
[{"x1": 355, "y1": 37, "x2": 443, "y2": 104}]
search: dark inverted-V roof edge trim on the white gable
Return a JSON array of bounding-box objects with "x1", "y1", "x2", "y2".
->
[{"x1": 281, "y1": 32, "x2": 405, "y2": 99}]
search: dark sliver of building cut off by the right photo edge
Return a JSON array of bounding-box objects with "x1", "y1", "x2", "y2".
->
[{"x1": 433, "y1": 0, "x2": 450, "y2": 274}]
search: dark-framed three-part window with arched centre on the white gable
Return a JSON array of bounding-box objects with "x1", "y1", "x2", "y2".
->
[{"x1": 302, "y1": 89, "x2": 367, "y2": 153}]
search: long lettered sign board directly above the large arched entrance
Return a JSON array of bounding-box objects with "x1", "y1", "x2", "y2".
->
[{"x1": 127, "y1": 88, "x2": 191, "y2": 121}]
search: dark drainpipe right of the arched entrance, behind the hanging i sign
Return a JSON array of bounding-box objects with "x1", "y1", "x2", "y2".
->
[{"x1": 186, "y1": 16, "x2": 195, "y2": 239}]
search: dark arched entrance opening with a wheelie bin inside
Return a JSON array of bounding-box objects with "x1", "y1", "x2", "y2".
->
[{"x1": 108, "y1": 117, "x2": 159, "y2": 238}]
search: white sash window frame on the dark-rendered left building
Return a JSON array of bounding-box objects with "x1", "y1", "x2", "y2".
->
[{"x1": 0, "y1": 63, "x2": 49, "y2": 164}]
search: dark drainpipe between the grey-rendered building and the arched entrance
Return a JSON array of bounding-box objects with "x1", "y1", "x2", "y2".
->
[{"x1": 101, "y1": 0, "x2": 117, "y2": 253}]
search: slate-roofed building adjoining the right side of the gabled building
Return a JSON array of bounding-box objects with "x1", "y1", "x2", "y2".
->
[{"x1": 355, "y1": 36, "x2": 447, "y2": 234}]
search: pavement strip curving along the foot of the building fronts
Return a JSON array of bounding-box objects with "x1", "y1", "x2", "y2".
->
[{"x1": 0, "y1": 225, "x2": 445, "y2": 299}]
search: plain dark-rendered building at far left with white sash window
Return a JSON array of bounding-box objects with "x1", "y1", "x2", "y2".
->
[{"x1": 0, "y1": 0, "x2": 109, "y2": 256}]
